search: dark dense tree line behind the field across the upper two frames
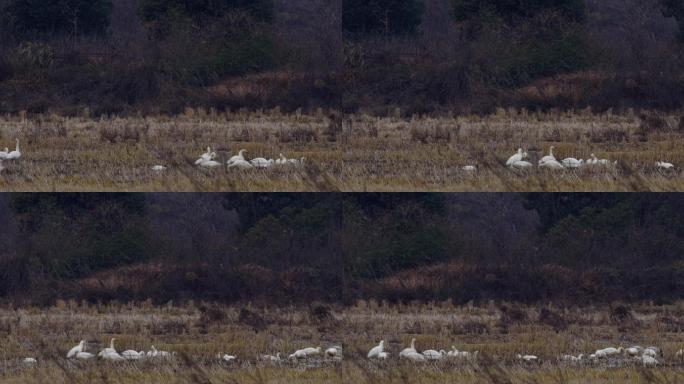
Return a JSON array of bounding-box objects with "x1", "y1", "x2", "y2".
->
[{"x1": 0, "y1": 0, "x2": 684, "y2": 115}]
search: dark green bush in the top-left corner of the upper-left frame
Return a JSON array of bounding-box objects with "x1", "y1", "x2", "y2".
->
[{"x1": 0, "y1": 0, "x2": 112, "y2": 37}]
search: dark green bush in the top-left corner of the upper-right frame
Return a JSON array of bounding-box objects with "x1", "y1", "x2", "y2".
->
[{"x1": 342, "y1": 0, "x2": 425, "y2": 35}]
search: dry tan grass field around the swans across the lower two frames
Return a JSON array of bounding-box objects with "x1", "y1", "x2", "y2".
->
[{"x1": 0, "y1": 302, "x2": 684, "y2": 384}]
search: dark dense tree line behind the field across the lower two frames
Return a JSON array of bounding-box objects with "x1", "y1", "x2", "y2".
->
[{"x1": 0, "y1": 194, "x2": 684, "y2": 303}]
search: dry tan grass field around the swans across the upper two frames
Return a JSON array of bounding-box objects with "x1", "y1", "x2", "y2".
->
[{"x1": 0, "y1": 109, "x2": 684, "y2": 192}]
